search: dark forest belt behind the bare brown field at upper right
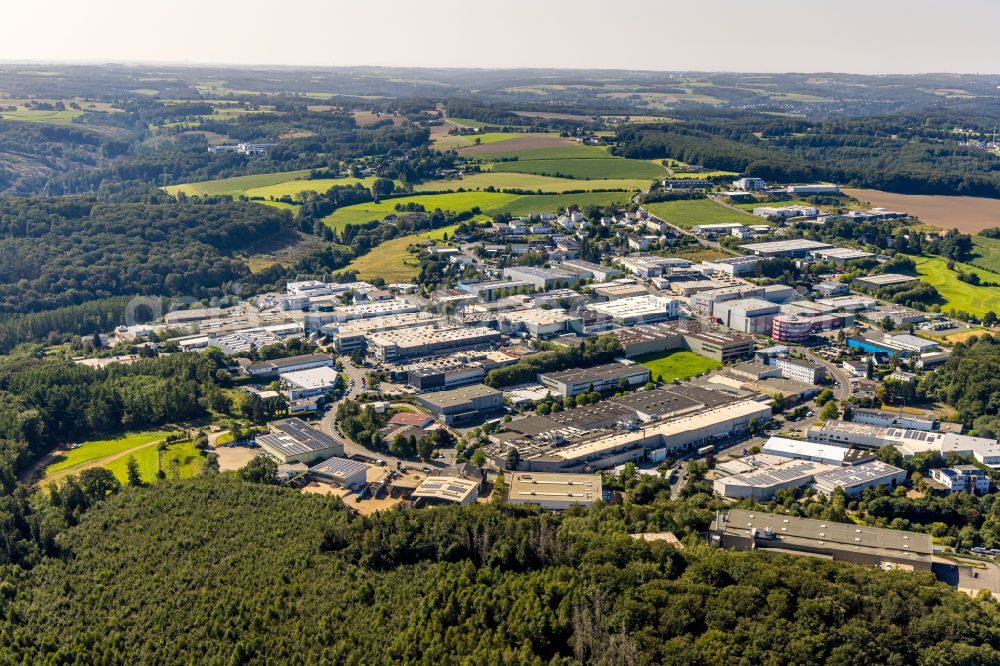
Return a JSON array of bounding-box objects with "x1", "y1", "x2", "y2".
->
[{"x1": 613, "y1": 114, "x2": 1000, "y2": 197}]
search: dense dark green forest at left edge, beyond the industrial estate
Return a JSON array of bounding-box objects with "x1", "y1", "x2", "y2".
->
[{"x1": 0, "y1": 197, "x2": 290, "y2": 313}]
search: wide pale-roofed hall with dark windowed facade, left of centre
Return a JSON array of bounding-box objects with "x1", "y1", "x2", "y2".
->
[{"x1": 368, "y1": 325, "x2": 500, "y2": 362}]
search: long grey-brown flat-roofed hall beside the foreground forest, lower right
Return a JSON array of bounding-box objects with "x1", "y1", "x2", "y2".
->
[{"x1": 709, "y1": 509, "x2": 933, "y2": 571}]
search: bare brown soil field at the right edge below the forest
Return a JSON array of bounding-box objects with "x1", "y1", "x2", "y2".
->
[{"x1": 844, "y1": 189, "x2": 1000, "y2": 234}]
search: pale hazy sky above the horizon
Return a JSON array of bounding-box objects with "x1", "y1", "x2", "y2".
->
[{"x1": 0, "y1": 0, "x2": 1000, "y2": 73}]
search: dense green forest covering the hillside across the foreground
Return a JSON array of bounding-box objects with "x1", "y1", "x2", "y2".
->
[{"x1": 0, "y1": 477, "x2": 1000, "y2": 664}]
